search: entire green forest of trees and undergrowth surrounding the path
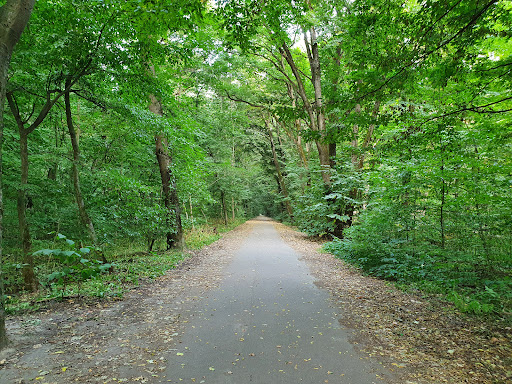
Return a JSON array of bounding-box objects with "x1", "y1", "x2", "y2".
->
[{"x1": 0, "y1": 0, "x2": 512, "y2": 348}]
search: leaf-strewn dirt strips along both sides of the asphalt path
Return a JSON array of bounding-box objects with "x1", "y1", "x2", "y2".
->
[{"x1": 0, "y1": 221, "x2": 512, "y2": 384}]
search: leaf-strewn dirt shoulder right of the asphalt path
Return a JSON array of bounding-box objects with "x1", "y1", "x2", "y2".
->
[{"x1": 275, "y1": 223, "x2": 512, "y2": 384}]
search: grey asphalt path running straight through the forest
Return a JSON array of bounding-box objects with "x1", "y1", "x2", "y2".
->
[{"x1": 163, "y1": 218, "x2": 394, "y2": 384}]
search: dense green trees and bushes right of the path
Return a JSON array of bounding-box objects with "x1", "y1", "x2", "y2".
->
[{"x1": 214, "y1": 0, "x2": 512, "y2": 315}]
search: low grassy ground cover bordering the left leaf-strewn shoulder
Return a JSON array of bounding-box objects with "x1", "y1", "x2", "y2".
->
[{"x1": 3, "y1": 220, "x2": 243, "y2": 315}]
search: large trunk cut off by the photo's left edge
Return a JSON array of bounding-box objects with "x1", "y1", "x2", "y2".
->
[{"x1": 0, "y1": 0, "x2": 35, "y2": 349}]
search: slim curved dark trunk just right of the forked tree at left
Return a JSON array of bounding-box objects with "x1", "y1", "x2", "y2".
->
[{"x1": 64, "y1": 86, "x2": 98, "y2": 245}]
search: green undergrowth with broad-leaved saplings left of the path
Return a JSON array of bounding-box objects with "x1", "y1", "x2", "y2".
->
[{"x1": 3, "y1": 220, "x2": 243, "y2": 315}]
